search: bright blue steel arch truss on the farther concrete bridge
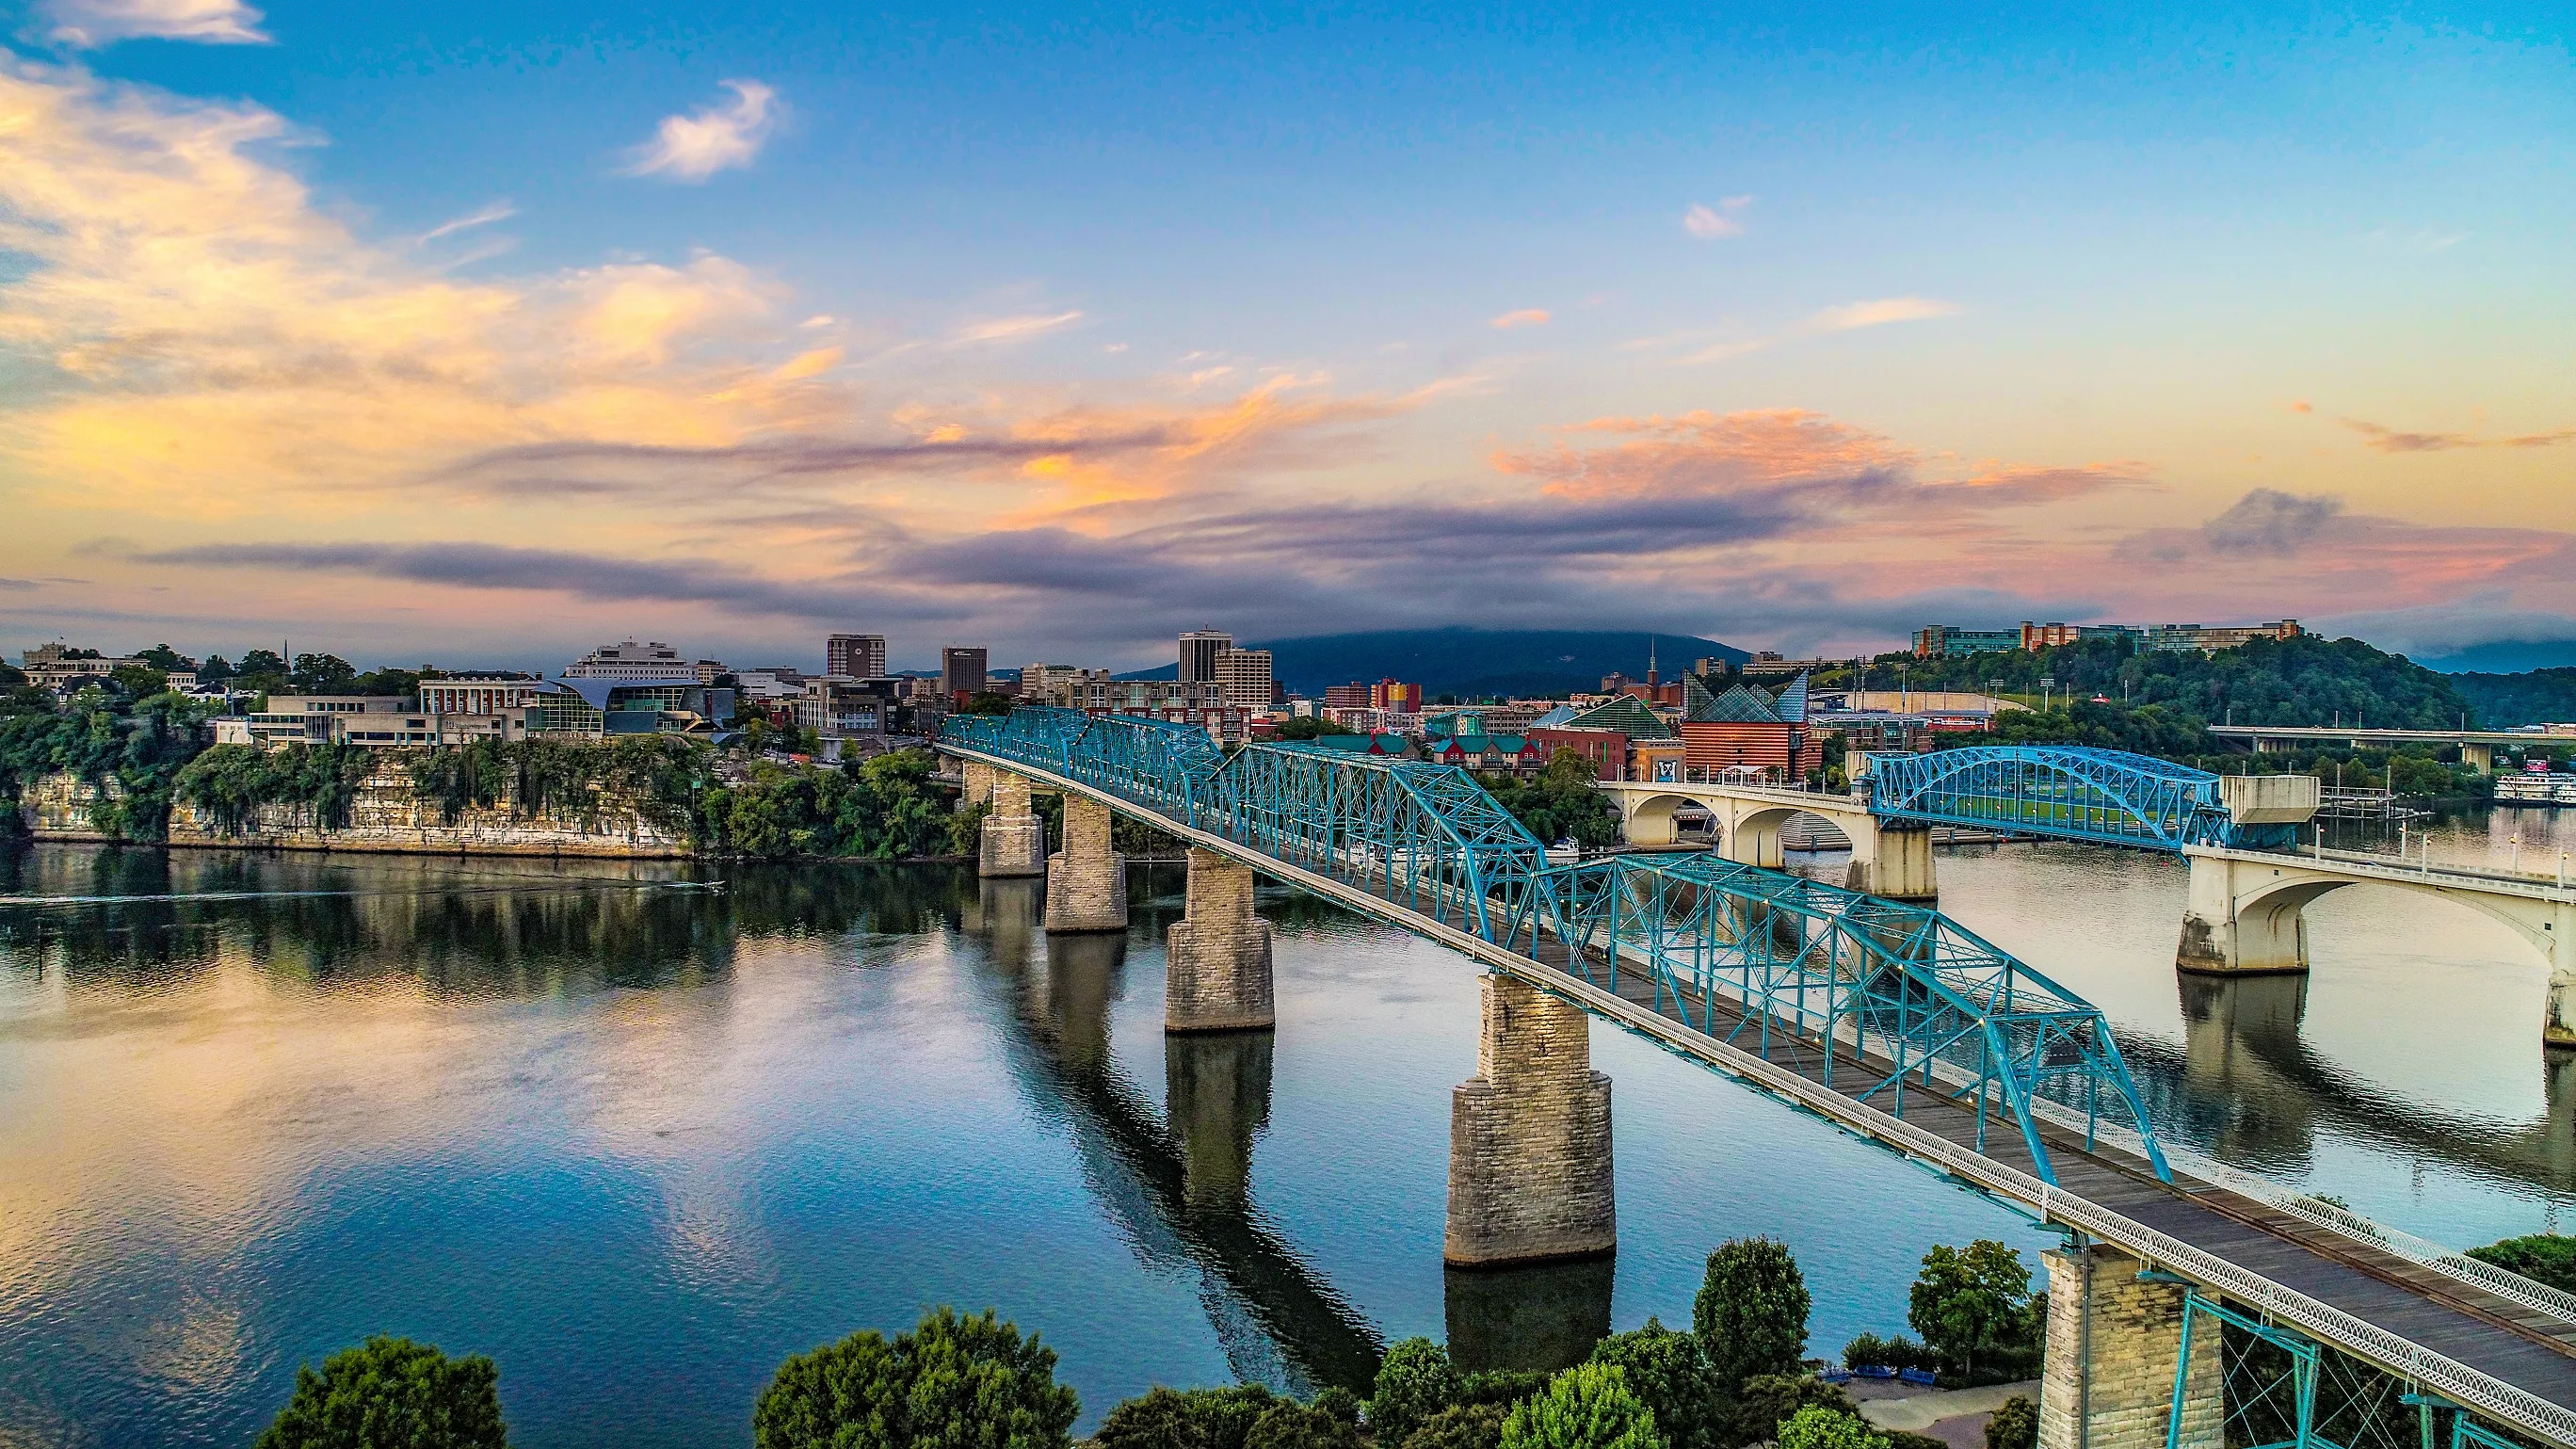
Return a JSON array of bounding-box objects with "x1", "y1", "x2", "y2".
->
[{"x1": 1868, "y1": 745, "x2": 2298, "y2": 851}]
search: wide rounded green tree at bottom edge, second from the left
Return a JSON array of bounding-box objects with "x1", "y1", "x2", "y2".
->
[{"x1": 752, "y1": 1305, "x2": 1082, "y2": 1449}]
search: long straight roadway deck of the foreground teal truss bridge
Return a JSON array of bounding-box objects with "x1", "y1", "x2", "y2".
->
[{"x1": 941, "y1": 740, "x2": 2576, "y2": 1449}]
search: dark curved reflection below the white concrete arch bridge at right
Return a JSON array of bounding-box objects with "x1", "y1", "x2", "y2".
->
[{"x1": 2117, "y1": 972, "x2": 2576, "y2": 1191}]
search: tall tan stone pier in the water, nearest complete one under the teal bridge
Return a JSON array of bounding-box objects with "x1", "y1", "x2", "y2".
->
[{"x1": 1442, "y1": 974, "x2": 1618, "y2": 1268}]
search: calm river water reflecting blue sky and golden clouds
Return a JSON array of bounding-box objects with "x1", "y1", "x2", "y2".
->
[{"x1": 0, "y1": 813, "x2": 2576, "y2": 1449}]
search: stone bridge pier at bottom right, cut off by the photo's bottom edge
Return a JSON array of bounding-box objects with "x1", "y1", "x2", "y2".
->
[{"x1": 2040, "y1": 1246, "x2": 2226, "y2": 1449}]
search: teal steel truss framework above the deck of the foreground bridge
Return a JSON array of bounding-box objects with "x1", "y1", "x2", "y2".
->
[{"x1": 941, "y1": 709, "x2": 2171, "y2": 1183}]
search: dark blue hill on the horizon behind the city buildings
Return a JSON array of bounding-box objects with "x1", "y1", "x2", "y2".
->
[{"x1": 1118, "y1": 629, "x2": 1751, "y2": 699}]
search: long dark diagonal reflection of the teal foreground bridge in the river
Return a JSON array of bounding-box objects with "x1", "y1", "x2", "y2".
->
[{"x1": 963, "y1": 879, "x2": 1383, "y2": 1393}]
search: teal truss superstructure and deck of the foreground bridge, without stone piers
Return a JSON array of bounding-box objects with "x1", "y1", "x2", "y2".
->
[{"x1": 938, "y1": 709, "x2": 2576, "y2": 1449}]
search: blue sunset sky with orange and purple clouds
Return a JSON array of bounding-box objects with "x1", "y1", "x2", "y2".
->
[{"x1": 0, "y1": 0, "x2": 2576, "y2": 668}]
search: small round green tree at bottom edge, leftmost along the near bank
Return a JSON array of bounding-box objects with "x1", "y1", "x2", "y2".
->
[{"x1": 255, "y1": 1333, "x2": 510, "y2": 1449}]
